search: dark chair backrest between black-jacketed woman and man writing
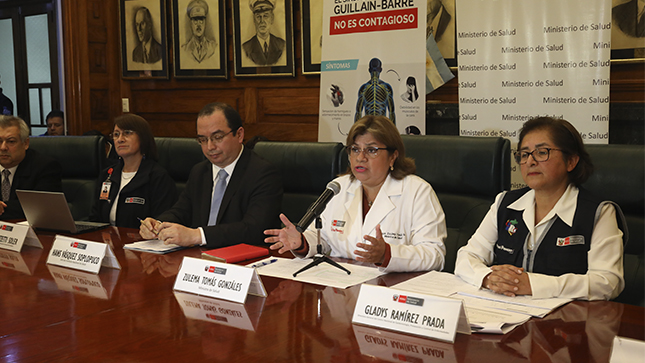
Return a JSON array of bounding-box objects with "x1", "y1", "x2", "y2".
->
[{"x1": 155, "y1": 137, "x2": 206, "y2": 193}]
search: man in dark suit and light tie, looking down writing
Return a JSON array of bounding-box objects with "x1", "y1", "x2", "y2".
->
[{"x1": 139, "y1": 102, "x2": 282, "y2": 248}]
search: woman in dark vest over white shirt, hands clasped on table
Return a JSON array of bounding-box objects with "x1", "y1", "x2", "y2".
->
[{"x1": 455, "y1": 117, "x2": 624, "y2": 300}]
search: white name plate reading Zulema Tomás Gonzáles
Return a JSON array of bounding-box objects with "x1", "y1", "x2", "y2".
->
[{"x1": 174, "y1": 257, "x2": 267, "y2": 303}]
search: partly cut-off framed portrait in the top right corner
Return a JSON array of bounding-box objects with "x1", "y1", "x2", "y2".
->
[{"x1": 611, "y1": 0, "x2": 645, "y2": 62}]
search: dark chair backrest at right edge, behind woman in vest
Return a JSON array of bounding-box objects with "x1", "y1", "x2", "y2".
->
[{"x1": 583, "y1": 145, "x2": 645, "y2": 306}]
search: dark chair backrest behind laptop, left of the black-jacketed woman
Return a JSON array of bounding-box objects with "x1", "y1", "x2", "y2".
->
[{"x1": 29, "y1": 136, "x2": 107, "y2": 220}]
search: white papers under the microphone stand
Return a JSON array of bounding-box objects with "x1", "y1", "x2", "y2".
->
[{"x1": 247, "y1": 257, "x2": 383, "y2": 289}]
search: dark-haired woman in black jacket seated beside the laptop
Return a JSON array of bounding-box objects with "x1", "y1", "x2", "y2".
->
[{"x1": 90, "y1": 114, "x2": 177, "y2": 229}]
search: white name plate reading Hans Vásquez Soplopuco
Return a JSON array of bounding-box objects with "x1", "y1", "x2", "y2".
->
[{"x1": 47, "y1": 235, "x2": 121, "y2": 274}]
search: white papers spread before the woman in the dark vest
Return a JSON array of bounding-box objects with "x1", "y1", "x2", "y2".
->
[{"x1": 393, "y1": 271, "x2": 571, "y2": 334}]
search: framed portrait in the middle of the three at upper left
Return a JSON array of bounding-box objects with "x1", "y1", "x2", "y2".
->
[{"x1": 171, "y1": 0, "x2": 228, "y2": 79}]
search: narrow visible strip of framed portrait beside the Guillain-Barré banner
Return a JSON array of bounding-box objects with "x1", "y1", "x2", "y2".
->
[{"x1": 300, "y1": 0, "x2": 323, "y2": 74}]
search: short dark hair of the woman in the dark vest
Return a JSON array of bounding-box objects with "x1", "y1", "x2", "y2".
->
[{"x1": 517, "y1": 117, "x2": 593, "y2": 186}]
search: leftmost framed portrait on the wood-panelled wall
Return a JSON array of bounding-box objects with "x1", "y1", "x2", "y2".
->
[{"x1": 119, "y1": 0, "x2": 168, "y2": 79}]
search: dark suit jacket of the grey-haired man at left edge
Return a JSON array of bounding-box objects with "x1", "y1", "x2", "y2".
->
[{"x1": 0, "y1": 149, "x2": 63, "y2": 220}]
